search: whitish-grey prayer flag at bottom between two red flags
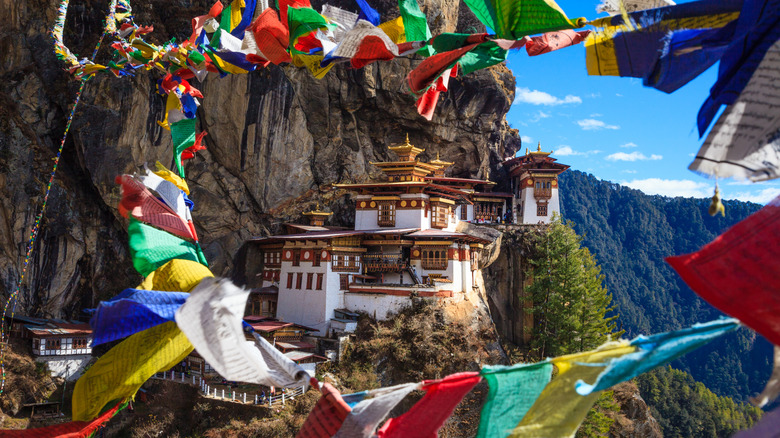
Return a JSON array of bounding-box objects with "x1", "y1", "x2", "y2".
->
[{"x1": 335, "y1": 383, "x2": 422, "y2": 438}]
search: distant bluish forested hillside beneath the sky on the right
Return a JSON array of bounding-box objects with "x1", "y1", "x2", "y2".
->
[{"x1": 560, "y1": 171, "x2": 772, "y2": 400}]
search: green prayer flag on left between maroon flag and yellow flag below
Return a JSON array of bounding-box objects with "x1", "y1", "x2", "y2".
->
[{"x1": 127, "y1": 216, "x2": 208, "y2": 277}]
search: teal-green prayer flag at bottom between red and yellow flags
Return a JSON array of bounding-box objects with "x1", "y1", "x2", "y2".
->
[{"x1": 477, "y1": 362, "x2": 552, "y2": 438}]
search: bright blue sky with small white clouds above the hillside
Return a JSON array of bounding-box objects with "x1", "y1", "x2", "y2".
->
[{"x1": 507, "y1": 0, "x2": 780, "y2": 204}]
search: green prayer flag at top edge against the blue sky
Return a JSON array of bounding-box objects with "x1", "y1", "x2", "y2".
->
[{"x1": 464, "y1": 0, "x2": 586, "y2": 40}]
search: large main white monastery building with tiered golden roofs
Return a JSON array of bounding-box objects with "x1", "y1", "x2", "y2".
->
[{"x1": 247, "y1": 138, "x2": 494, "y2": 336}]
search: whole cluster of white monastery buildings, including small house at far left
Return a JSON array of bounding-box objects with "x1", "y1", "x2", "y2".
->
[{"x1": 7, "y1": 136, "x2": 568, "y2": 379}]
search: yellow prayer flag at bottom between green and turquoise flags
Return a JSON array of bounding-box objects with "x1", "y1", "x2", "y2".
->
[{"x1": 510, "y1": 341, "x2": 636, "y2": 438}]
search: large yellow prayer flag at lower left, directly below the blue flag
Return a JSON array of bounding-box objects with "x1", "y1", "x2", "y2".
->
[{"x1": 73, "y1": 321, "x2": 193, "y2": 421}]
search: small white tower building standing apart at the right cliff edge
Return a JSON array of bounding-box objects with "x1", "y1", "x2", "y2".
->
[{"x1": 504, "y1": 143, "x2": 569, "y2": 224}]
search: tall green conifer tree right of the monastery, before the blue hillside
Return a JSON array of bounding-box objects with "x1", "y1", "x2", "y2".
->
[{"x1": 524, "y1": 215, "x2": 617, "y2": 358}]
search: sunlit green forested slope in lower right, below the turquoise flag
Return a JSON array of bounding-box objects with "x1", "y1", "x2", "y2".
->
[{"x1": 637, "y1": 367, "x2": 761, "y2": 438}]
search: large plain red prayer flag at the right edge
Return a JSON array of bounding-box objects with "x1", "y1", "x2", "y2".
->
[{"x1": 666, "y1": 197, "x2": 780, "y2": 345}]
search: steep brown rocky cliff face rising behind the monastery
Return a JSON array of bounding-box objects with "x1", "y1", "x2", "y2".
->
[{"x1": 0, "y1": 0, "x2": 520, "y2": 317}]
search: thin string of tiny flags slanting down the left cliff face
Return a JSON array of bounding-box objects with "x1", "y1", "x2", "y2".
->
[{"x1": 0, "y1": 9, "x2": 114, "y2": 395}]
